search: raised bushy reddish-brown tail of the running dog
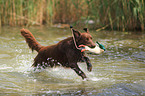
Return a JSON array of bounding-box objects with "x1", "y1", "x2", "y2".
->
[{"x1": 20, "y1": 28, "x2": 42, "y2": 52}]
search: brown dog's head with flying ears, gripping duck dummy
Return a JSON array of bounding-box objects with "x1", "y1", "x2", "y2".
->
[{"x1": 72, "y1": 28, "x2": 96, "y2": 48}]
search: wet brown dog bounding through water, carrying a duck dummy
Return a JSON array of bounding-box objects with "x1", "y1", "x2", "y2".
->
[{"x1": 20, "y1": 28, "x2": 96, "y2": 79}]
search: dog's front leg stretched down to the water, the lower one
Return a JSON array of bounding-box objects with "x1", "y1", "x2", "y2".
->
[{"x1": 69, "y1": 63, "x2": 87, "y2": 79}]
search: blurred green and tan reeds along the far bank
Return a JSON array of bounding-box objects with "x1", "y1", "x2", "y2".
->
[{"x1": 0, "y1": 0, "x2": 145, "y2": 31}]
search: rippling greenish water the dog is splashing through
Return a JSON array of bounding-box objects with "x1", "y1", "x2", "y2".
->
[{"x1": 0, "y1": 27, "x2": 145, "y2": 96}]
